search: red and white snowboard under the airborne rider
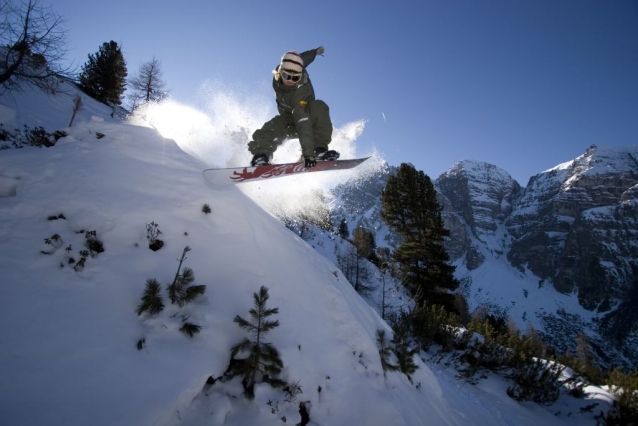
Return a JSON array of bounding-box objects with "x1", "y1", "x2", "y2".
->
[{"x1": 203, "y1": 157, "x2": 370, "y2": 185}]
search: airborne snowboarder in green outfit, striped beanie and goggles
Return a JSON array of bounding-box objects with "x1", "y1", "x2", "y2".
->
[{"x1": 248, "y1": 46, "x2": 339, "y2": 168}]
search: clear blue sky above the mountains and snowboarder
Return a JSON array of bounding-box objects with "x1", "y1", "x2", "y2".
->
[{"x1": 52, "y1": 0, "x2": 638, "y2": 186}]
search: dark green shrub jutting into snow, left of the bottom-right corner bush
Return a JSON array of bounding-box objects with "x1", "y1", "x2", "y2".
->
[{"x1": 507, "y1": 358, "x2": 565, "y2": 405}]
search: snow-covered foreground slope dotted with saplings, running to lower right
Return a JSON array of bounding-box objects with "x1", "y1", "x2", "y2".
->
[{"x1": 0, "y1": 81, "x2": 620, "y2": 425}]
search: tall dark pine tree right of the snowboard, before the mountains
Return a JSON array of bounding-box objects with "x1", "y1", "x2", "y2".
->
[{"x1": 381, "y1": 163, "x2": 459, "y2": 310}]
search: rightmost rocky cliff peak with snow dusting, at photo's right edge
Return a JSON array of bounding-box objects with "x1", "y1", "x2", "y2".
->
[{"x1": 506, "y1": 146, "x2": 638, "y2": 311}]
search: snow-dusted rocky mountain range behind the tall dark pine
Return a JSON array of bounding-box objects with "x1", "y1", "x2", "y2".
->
[{"x1": 333, "y1": 146, "x2": 638, "y2": 367}]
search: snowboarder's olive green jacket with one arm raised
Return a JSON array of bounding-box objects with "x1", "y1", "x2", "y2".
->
[{"x1": 272, "y1": 49, "x2": 317, "y2": 156}]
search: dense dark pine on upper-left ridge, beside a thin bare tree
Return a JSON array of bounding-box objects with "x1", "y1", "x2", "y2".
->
[{"x1": 80, "y1": 40, "x2": 127, "y2": 105}]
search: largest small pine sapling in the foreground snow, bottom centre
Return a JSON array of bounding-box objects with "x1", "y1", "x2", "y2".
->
[{"x1": 230, "y1": 286, "x2": 286, "y2": 399}]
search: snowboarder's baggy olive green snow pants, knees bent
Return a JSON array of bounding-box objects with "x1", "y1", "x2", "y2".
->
[{"x1": 248, "y1": 100, "x2": 332, "y2": 157}]
